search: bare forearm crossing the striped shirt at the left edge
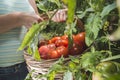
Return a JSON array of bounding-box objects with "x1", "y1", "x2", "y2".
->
[{"x1": 0, "y1": 13, "x2": 22, "y2": 33}]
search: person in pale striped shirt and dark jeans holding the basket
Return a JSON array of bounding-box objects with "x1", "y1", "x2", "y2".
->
[{"x1": 0, "y1": 0, "x2": 66, "y2": 80}]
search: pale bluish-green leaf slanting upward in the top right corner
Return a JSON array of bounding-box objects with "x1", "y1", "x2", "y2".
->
[{"x1": 101, "y1": 2, "x2": 116, "y2": 18}]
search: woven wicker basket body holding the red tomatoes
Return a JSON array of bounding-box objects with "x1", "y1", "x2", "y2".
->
[{"x1": 24, "y1": 52, "x2": 63, "y2": 80}]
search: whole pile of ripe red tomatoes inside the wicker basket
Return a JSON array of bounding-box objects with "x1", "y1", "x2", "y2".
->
[{"x1": 39, "y1": 32, "x2": 85, "y2": 59}]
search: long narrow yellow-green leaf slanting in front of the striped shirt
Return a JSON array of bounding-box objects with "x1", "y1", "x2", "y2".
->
[{"x1": 18, "y1": 21, "x2": 48, "y2": 50}]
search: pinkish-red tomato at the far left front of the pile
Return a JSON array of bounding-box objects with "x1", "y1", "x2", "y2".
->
[{"x1": 39, "y1": 45, "x2": 49, "y2": 59}]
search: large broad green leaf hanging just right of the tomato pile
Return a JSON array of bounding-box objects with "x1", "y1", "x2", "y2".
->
[{"x1": 85, "y1": 13, "x2": 102, "y2": 46}]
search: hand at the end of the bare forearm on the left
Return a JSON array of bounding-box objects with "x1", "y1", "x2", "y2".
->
[{"x1": 19, "y1": 13, "x2": 43, "y2": 28}]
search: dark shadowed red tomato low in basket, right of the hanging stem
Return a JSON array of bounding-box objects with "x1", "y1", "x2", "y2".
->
[{"x1": 69, "y1": 43, "x2": 84, "y2": 55}]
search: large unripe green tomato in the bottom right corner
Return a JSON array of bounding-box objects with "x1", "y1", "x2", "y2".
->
[{"x1": 92, "y1": 61, "x2": 120, "y2": 80}]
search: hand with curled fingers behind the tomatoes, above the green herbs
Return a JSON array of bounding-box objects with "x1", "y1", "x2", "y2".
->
[{"x1": 52, "y1": 9, "x2": 67, "y2": 22}]
